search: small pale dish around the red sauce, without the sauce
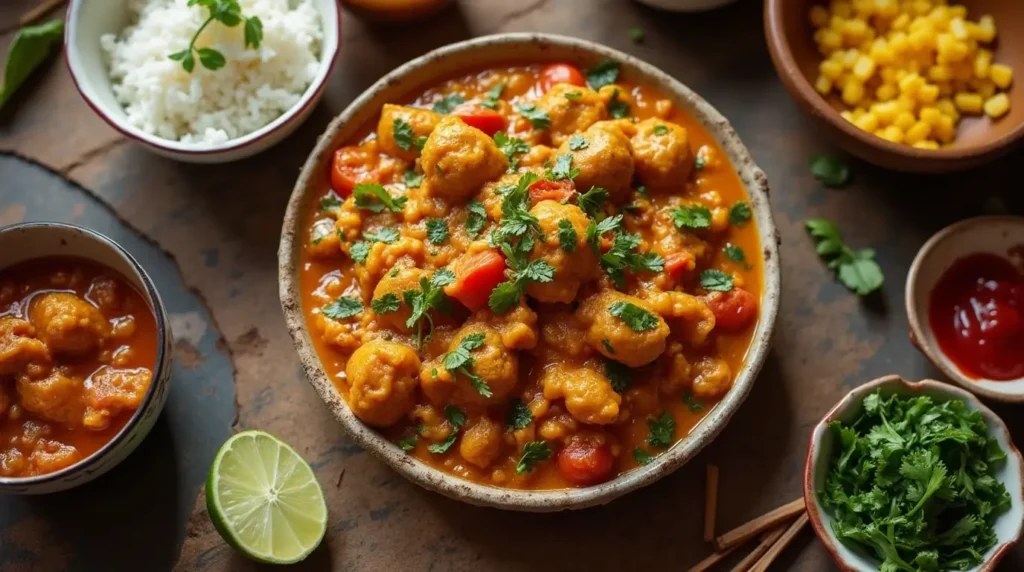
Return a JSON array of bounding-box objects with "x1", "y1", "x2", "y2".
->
[{"x1": 904, "y1": 216, "x2": 1024, "y2": 403}]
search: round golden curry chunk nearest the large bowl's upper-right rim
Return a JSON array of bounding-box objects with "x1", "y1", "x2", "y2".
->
[{"x1": 633, "y1": 118, "x2": 694, "y2": 191}]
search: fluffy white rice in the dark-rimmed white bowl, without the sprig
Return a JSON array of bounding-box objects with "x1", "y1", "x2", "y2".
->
[{"x1": 100, "y1": 0, "x2": 323, "y2": 144}]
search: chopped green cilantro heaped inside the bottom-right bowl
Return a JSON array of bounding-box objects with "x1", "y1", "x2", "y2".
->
[{"x1": 818, "y1": 392, "x2": 1010, "y2": 572}]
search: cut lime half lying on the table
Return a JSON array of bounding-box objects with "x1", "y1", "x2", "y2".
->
[{"x1": 206, "y1": 431, "x2": 327, "y2": 564}]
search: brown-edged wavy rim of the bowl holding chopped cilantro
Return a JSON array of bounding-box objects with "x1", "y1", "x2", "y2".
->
[{"x1": 804, "y1": 375, "x2": 1024, "y2": 572}]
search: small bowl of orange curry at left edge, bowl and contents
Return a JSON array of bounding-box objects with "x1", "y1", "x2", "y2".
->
[{"x1": 0, "y1": 222, "x2": 170, "y2": 494}]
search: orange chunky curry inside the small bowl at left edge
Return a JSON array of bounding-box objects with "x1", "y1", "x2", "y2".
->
[{"x1": 0, "y1": 257, "x2": 157, "y2": 477}]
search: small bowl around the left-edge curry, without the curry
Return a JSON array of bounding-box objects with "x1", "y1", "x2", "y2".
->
[{"x1": 0, "y1": 222, "x2": 172, "y2": 494}]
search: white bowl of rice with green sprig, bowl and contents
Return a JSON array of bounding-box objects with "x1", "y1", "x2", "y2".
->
[{"x1": 65, "y1": 0, "x2": 341, "y2": 163}]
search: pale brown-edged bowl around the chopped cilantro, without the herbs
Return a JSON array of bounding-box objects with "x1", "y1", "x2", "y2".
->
[{"x1": 804, "y1": 376, "x2": 1024, "y2": 572}]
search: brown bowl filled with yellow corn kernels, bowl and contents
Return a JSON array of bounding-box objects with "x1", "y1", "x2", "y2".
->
[{"x1": 765, "y1": 0, "x2": 1024, "y2": 173}]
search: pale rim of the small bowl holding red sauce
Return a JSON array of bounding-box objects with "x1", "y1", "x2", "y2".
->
[{"x1": 903, "y1": 215, "x2": 1024, "y2": 403}]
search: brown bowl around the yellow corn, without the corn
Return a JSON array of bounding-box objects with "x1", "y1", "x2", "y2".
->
[{"x1": 764, "y1": 0, "x2": 1024, "y2": 173}]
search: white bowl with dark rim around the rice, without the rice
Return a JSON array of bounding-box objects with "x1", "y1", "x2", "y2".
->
[{"x1": 65, "y1": 0, "x2": 341, "y2": 163}]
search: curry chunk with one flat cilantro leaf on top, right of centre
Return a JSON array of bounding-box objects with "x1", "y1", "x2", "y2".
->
[{"x1": 577, "y1": 291, "x2": 669, "y2": 367}]
